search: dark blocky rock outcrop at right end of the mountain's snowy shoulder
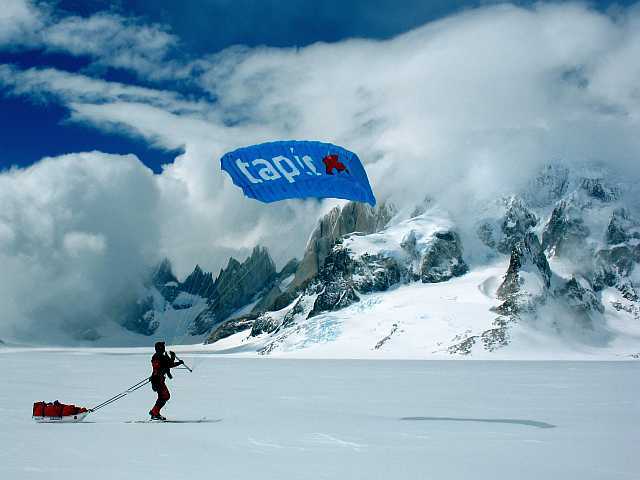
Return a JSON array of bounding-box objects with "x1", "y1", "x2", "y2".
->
[{"x1": 420, "y1": 232, "x2": 469, "y2": 283}]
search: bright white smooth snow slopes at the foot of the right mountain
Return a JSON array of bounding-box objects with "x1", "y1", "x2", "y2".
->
[{"x1": 204, "y1": 259, "x2": 640, "y2": 360}]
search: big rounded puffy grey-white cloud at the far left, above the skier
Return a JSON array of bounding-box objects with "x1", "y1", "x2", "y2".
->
[{"x1": 0, "y1": 152, "x2": 161, "y2": 343}]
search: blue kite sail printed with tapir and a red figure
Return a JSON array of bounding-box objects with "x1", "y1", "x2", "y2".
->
[{"x1": 220, "y1": 141, "x2": 376, "y2": 206}]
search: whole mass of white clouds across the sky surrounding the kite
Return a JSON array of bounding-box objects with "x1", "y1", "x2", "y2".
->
[{"x1": 0, "y1": 4, "x2": 640, "y2": 344}]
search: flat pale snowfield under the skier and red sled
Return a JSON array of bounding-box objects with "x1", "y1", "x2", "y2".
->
[{"x1": 0, "y1": 347, "x2": 640, "y2": 480}]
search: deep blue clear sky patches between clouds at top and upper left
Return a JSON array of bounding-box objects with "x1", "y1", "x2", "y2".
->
[{"x1": 0, "y1": 0, "x2": 540, "y2": 172}]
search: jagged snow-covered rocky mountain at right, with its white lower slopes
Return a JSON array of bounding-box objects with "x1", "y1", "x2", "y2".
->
[{"x1": 202, "y1": 165, "x2": 640, "y2": 358}]
